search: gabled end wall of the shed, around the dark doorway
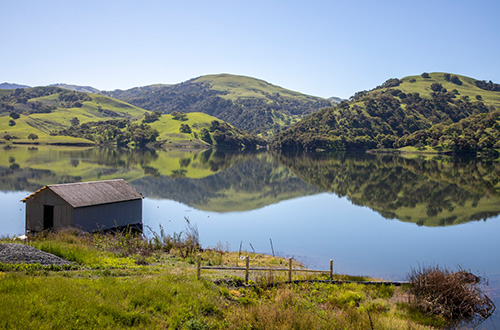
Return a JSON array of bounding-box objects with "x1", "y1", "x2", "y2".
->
[{"x1": 26, "y1": 189, "x2": 73, "y2": 231}]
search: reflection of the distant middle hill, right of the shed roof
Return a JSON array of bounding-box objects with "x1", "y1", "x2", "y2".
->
[{"x1": 131, "y1": 154, "x2": 320, "y2": 212}]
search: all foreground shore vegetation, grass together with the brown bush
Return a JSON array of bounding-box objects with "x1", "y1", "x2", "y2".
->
[{"x1": 0, "y1": 227, "x2": 494, "y2": 329}]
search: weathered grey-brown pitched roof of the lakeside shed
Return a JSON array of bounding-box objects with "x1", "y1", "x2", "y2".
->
[{"x1": 22, "y1": 179, "x2": 143, "y2": 208}]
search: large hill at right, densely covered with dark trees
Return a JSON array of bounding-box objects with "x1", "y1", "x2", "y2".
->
[{"x1": 272, "y1": 73, "x2": 500, "y2": 152}]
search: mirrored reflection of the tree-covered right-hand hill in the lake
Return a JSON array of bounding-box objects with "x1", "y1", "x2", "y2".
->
[{"x1": 277, "y1": 154, "x2": 500, "y2": 226}]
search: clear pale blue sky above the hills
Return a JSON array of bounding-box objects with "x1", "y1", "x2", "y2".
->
[{"x1": 0, "y1": 0, "x2": 500, "y2": 98}]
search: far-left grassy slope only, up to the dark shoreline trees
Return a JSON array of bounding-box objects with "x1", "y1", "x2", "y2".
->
[{"x1": 0, "y1": 87, "x2": 147, "y2": 144}]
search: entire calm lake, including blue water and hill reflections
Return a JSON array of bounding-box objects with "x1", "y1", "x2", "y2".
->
[{"x1": 0, "y1": 146, "x2": 500, "y2": 327}]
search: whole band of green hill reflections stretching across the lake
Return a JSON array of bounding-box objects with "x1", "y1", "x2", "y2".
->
[{"x1": 0, "y1": 146, "x2": 500, "y2": 226}]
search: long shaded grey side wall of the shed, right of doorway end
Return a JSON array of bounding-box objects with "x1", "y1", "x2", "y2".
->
[{"x1": 73, "y1": 200, "x2": 142, "y2": 231}]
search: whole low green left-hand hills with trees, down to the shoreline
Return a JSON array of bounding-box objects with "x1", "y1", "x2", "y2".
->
[{"x1": 0, "y1": 87, "x2": 263, "y2": 149}]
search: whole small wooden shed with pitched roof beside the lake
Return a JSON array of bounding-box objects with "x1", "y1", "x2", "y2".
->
[{"x1": 22, "y1": 179, "x2": 143, "y2": 232}]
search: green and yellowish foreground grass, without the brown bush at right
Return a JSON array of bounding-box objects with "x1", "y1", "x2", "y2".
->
[{"x1": 0, "y1": 231, "x2": 440, "y2": 329}]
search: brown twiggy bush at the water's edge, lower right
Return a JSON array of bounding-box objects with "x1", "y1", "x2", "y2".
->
[{"x1": 409, "y1": 266, "x2": 495, "y2": 322}]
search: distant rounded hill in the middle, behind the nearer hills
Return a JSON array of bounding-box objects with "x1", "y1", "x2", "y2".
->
[{"x1": 104, "y1": 74, "x2": 331, "y2": 136}]
